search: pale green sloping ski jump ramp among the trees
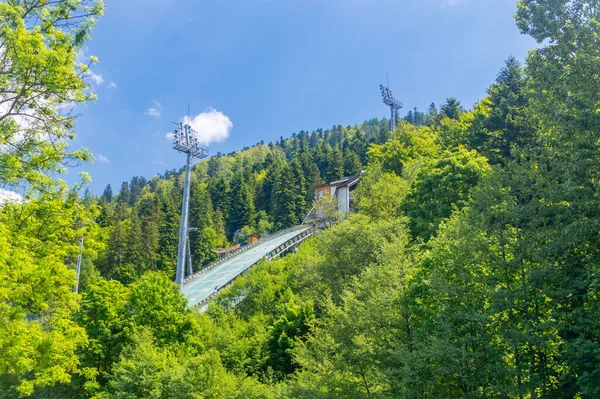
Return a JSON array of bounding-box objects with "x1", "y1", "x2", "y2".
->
[{"x1": 182, "y1": 225, "x2": 314, "y2": 307}]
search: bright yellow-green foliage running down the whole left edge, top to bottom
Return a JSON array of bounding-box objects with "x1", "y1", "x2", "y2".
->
[{"x1": 0, "y1": 0, "x2": 103, "y2": 396}]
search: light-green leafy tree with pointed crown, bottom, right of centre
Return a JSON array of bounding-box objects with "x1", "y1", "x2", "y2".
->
[{"x1": 289, "y1": 227, "x2": 414, "y2": 398}]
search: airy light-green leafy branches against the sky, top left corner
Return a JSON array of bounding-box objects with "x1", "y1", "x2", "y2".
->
[{"x1": 0, "y1": 0, "x2": 104, "y2": 194}]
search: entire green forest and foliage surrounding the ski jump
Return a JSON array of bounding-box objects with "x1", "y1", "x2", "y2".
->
[{"x1": 0, "y1": 0, "x2": 600, "y2": 399}]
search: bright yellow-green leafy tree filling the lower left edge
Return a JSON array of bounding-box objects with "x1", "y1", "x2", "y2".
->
[{"x1": 0, "y1": 194, "x2": 98, "y2": 395}]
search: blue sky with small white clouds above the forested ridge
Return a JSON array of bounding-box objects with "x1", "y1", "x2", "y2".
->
[{"x1": 69, "y1": 0, "x2": 535, "y2": 193}]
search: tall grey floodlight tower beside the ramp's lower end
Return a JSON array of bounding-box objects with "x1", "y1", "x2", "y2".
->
[{"x1": 173, "y1": 122, "x2": 208, "y2": 289}]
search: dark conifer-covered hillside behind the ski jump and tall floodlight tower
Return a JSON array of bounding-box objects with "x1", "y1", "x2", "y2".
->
[{"x1": 82, "y1": 119, "x2": 389, "y2": 284}]
